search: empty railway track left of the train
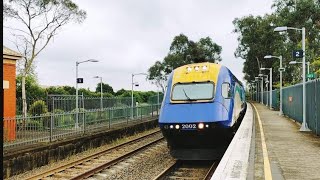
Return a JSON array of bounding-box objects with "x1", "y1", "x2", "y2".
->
[{"x1": 27, "y1": 131, "x2": 164, "y2": 180}]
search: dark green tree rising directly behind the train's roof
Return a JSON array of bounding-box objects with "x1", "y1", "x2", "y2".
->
[{"x1": 148, "y1": 34, "x2": 222, "y2": 92}]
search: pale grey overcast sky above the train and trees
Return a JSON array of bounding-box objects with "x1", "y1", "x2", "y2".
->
[{"x1": 4, "y1": 0, "x2": 273, "y2": 91}]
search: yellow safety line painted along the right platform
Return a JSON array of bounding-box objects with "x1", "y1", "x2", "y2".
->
[{"x1": 252, "y1": 104, "x2": 272, "y2": 180}]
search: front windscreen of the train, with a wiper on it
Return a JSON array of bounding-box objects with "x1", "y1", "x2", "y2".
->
[{"x1": 171, "y1": 82, "x2": 214, "y2": 101}]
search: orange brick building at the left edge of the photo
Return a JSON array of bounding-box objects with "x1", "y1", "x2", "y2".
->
[{"x1": 2, "y1": 46, "x2": 22, "y2": 141}]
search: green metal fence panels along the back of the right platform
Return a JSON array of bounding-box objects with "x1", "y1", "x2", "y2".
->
[{"x1": 252, "y1": 79, "x2": 320, "y2": 135}]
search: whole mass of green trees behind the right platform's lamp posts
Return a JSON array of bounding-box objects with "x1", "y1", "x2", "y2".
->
[{"x1": 233, "y1": 0, "x2": 320, "y2": 84}]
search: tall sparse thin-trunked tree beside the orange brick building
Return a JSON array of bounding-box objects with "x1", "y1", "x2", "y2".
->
[{"x1": 3, "y1": 0, "x2": 86, "y2": 117}]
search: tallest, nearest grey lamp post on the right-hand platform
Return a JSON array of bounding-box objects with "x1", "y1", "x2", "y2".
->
[{"x1": 273, "y1": 26, "x2": 310, "y2": 131}]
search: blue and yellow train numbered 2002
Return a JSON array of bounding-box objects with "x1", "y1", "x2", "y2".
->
[{"x1": 159, "y1": 62, "x2": 246, "y2": 160}]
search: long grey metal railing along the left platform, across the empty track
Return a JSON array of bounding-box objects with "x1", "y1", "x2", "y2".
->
[{"x1": 3, "y1": 104, "x2": 160, "y2": 148}]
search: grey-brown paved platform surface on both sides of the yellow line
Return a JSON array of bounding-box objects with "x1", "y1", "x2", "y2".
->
[{"x1": 253, "y1": 103, "x2": 320, "y2": 180}]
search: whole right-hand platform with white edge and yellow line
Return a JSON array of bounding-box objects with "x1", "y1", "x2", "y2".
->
[{"x1": 211, "y1": 103, "x2": 320, "y2": 180}]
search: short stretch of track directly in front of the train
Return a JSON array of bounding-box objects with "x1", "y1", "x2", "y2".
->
[{"x1": 154, "y1": 160, "x2": 219, "y2": 180}]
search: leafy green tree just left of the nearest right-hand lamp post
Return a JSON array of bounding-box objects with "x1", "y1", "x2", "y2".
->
[{"x1": 233, "y1": 15, "x2": 283, "y2": 81}]
